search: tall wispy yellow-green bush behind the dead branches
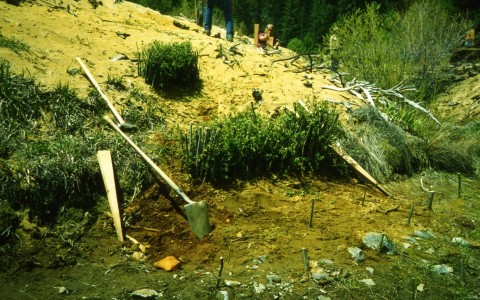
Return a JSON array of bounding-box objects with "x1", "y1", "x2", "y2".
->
[{"x1": 337, "y1": 0, "x2": 466, "y2": 100}]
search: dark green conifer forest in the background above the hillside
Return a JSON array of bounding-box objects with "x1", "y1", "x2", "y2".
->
[{"x1": 131, "y1": 0, "x2": 480, "y2": 51}]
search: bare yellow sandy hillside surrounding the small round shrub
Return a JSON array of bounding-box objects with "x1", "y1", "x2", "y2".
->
[{"x1": 0, "y1": 1, "x2": 356, "y2": 124}]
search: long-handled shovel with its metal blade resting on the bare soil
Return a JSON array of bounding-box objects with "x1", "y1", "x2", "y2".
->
[{"x1": 103, "y1": 116, "x2": 212, "y2": 240}]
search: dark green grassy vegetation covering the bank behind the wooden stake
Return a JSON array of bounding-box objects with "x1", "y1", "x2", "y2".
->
[{"x1": 0, "y1": 61, "x2": 165, "y2": 223}]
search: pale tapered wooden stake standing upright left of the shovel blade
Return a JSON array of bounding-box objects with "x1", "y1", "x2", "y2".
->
[{"x1": 97, "y1": 150, "x2": 123, "y2": 242}]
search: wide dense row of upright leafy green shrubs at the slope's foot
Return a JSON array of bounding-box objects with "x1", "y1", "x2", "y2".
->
[{"x1": 183, "y1": 104, "x2": 337, "y2": 182}]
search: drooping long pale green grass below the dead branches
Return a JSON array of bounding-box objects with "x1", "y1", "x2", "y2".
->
[{"x1": 341, "y1": 107, "x2": 480, "y2": 181}]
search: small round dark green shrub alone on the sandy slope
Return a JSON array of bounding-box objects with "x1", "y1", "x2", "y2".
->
[{"x1": 138, "y1": 41, "x2": 200, "y2": 91}]
